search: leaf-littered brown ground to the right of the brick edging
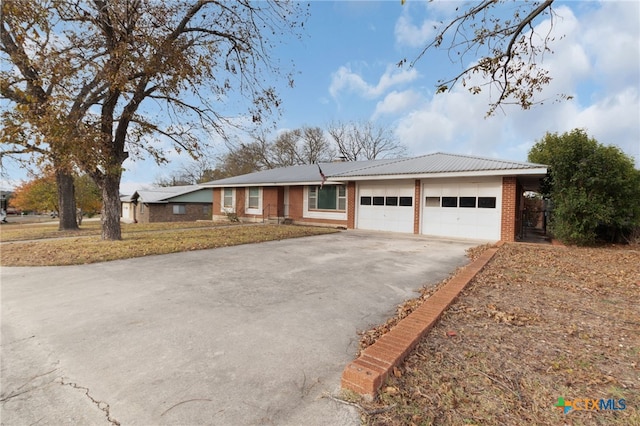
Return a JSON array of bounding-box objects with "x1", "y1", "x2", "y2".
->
[{"x1": 360, "y1": 244, "x2": 640, "y2": 426}]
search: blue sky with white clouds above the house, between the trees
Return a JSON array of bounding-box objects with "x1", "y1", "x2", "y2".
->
[{"x1": 3, "y1": 0, "x2": 640, "y2": 193}]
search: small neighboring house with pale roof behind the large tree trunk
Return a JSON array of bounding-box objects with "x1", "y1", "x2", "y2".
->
[{"x1": 120, "y1": 185, "x2": 213, "y2": 223}]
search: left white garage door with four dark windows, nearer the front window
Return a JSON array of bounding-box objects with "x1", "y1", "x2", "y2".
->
[{"x1": 356, "y1": 181, "x2": 415, "y2": 233}]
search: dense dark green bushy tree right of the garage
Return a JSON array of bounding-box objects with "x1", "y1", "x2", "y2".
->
[{"x1": 529, "y1": 129, "x2": 640, "y2": 245}]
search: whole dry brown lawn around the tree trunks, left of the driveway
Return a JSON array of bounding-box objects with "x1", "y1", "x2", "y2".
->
[{"x1": 0, "y1": 222, "x2": 337, "y2": 266}]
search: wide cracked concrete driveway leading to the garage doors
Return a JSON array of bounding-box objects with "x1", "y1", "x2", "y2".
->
[{"x1": 0, "y1": 231, "x2": 478, "y2": 425}]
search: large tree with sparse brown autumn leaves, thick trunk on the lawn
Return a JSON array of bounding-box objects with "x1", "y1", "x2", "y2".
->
[{"x1": 0, "y1": 0, "x2": 306, "y2": 240}]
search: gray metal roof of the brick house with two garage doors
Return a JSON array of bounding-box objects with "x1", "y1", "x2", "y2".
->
[{"x1": 202, "y1": 152, "x2": 547, "y2": 187}]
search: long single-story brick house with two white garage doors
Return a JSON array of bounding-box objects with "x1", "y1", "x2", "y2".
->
[{"x1": 201, "y1": 153, "x2": 547, "y2": 241}]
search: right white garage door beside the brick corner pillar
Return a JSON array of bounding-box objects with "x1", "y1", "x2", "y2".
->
[{"x1": 421, "y1": 178, "x2": 502, "y2": 241}]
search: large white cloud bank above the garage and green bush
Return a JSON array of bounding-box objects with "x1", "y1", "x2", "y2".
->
[{"x1": 390, "y1": 2, "x2": 640, "y2": 166}]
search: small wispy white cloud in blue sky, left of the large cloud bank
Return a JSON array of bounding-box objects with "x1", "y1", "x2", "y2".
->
[{"x1": 329, "y1": 65, "x2": 418, "y2": 99}]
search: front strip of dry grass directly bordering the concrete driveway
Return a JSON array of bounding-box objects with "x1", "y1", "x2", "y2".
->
[{"x1": 1, "y1": 225, "x2": 337, "y2": 266}]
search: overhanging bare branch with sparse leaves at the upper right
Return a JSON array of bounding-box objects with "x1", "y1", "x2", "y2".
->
[{"x1": 398, "y1": 0, "x2": 569, "y2": 115}]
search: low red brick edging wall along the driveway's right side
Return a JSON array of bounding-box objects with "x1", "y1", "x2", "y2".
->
[{"x1": 341, "y1": 241, "x2": 504, "y2": 398}]
